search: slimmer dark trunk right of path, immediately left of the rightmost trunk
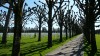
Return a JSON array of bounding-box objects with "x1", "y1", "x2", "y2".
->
[{"x1": 84, "y1": 0, "x2": 91, "y2": 44}]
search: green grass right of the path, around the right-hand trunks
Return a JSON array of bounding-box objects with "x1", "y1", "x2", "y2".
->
[{"x1": 84, "y1": 34, "x2": 100, "y2": 56}]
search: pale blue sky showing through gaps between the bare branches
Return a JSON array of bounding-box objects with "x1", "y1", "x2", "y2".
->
[{"x1": 0, "y1": 0, "x2": 100, "y2": 30}]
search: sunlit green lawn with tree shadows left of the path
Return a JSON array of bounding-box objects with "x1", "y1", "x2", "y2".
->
[{"x1": 0, "y1": 35, "x2": 76, "y2": 56}]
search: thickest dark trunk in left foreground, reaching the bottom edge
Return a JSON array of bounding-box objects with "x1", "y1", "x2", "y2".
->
[{"x1": 12, "y1": 0, "x2": 24, "y2": 56}]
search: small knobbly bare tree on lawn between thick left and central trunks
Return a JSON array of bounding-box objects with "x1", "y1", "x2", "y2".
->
[{"x1": 33, "y1": 2, "x2": 46, "y2": 41}]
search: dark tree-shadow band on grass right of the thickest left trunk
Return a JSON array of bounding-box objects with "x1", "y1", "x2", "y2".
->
[{"x1": 21, "y1": 43, "x2": 47, "y2": 56}]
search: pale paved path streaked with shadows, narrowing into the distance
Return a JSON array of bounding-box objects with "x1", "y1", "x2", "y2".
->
[{"x1": 46, "y1": 34, "x2": 83, "y2": 56}]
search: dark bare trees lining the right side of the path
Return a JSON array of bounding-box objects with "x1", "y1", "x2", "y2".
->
[{"x1": 75, "y1": 0, "x2": 100, "y2": 56}]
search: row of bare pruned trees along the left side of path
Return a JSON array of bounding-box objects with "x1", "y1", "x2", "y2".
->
[{"x1": 0, "y1": 0, "x2": 82, "y2": 56}]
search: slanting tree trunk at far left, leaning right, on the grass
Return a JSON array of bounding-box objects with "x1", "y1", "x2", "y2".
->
[{"x1": 1, "y1": 5, "x2": 11, "y2": 44}]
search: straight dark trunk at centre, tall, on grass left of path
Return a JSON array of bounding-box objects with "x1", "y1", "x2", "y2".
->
[{"x1": 48, "y1": 0, "x2": 53, "y2": 48}]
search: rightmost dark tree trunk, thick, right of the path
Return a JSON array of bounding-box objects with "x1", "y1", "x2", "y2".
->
[{"x1": 89, "y1": 0, "x2": 97, "y2": 52}]
